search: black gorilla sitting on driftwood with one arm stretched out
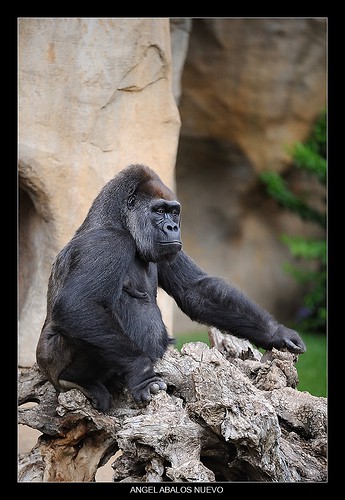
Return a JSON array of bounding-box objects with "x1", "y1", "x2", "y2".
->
[{"x1": 36, "y1": 164, "x2": 306, "y2": 412}]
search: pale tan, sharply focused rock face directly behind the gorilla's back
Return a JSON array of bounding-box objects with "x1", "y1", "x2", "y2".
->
[{"x1": 19, "y1": 18, "x2": 180, "y2": 366}]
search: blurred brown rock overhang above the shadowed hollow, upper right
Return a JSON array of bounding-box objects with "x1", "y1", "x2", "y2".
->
[{"x1": 180, "y1": 19, "x2": 326, "y2": 171}]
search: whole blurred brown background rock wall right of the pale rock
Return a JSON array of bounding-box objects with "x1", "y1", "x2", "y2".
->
[{"x1": 174, "y1": 19, "x2": 327, "y2": 332}]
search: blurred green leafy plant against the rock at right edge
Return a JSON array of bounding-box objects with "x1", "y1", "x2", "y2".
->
[{"x1": 260, "y1": 112, "x2": 327, "y2": 333}]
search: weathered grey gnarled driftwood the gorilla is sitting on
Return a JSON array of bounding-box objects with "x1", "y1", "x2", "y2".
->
[{"x1": 19, "y1": 329, "x2": 327, "y2": 482}]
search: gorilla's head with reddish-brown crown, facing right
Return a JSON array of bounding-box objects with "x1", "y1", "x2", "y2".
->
[{"x1": 78, "y1": 164, "x2": 182, "y2": 262}]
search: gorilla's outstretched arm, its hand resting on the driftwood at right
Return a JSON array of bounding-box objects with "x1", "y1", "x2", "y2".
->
[{"x1": 158, "y1": 251, "x2": 306, "y2": 353}]
